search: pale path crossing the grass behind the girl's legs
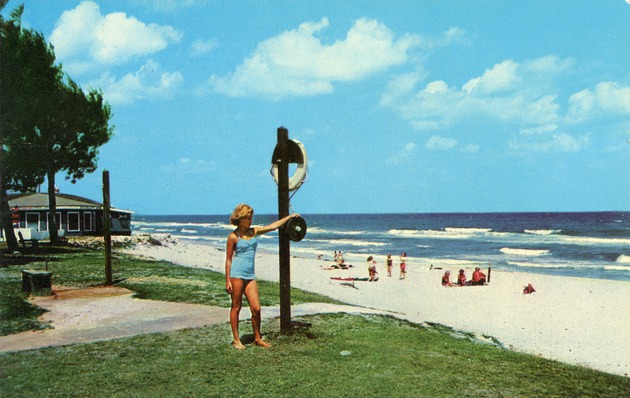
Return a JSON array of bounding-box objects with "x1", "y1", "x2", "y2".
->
[{"x1": 0, "y1": 287, "x2": 391, "y2": 353}]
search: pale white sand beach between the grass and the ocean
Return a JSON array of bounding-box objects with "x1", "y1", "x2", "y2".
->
[{"x1": 123, "y1": 236, "x2": 630, "y2": 376}]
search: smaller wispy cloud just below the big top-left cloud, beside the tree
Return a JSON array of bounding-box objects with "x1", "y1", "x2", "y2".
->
[{"x1": 93, "y1": 60, "x2": 184, "y2": 105}]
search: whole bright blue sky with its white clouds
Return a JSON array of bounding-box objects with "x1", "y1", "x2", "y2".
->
[{"x1": 4, "y1": 0, "x2": 630, "y2": 214}]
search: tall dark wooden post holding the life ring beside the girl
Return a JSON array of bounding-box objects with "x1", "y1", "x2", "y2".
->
[{"x1": 276, "y1": 127, "x2": 293, "y2": 335}]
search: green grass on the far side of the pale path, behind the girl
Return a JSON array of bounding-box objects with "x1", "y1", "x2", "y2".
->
[{"x1": 0, "y1": 247, "x2": 338, "y2": 335}]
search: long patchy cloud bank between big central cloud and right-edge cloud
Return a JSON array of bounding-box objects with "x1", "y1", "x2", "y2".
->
[{"x1": 381, "y1": 55, "x2": 573, "y2": 130}]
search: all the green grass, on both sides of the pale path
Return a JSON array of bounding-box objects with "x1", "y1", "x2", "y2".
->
[{"x1": 0, "y1": 244, "x2": 630, "y2": 397}]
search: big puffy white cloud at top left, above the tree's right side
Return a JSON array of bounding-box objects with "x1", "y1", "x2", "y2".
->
[{"x1": 50, "y1": 1, "x2": 183, "y2": 73}]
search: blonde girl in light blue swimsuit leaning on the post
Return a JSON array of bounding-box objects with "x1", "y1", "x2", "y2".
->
[{"x1": 225, "y1": 204, "x2": 299, "y2": 350}]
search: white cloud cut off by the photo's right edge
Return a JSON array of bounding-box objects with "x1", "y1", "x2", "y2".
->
[{"x1": 566, "y1": 81, "x2": 630, "y2": 123}]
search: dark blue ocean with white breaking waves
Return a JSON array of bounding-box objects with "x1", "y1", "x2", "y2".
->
[{"x1": 132, "y1": 212, "x2": 630, "y2": 281}]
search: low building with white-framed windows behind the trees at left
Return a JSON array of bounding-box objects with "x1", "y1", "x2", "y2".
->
[{"x1": 4, "y1": 193, "x2": 133, "y2": 239}]
